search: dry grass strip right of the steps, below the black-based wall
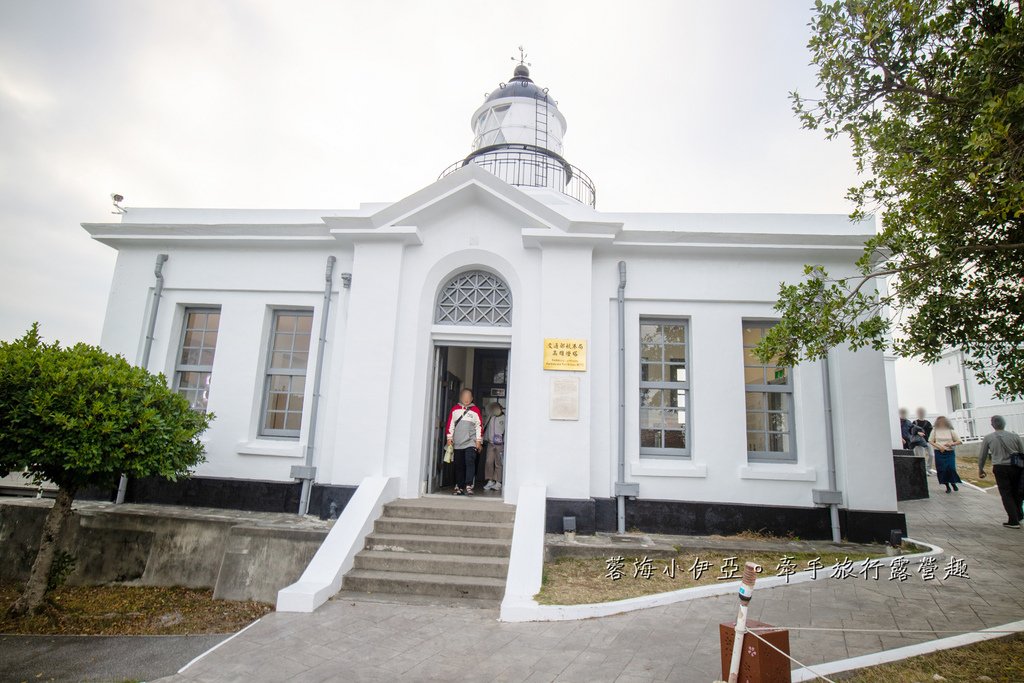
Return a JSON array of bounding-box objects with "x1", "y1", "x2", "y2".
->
[{"x1": 536, "y1": 550, "x2": 901, "y2": 605}]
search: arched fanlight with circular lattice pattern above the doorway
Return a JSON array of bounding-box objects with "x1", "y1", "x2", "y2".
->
[{"x1": 434, "y1": 270, "x2": 512, "y2": 327}]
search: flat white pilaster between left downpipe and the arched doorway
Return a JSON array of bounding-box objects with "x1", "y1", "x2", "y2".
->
[{"x1": 325, "y1": 241, "x2": 406, "y2": 481}]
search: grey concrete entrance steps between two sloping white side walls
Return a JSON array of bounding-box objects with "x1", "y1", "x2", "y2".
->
[{"x1": 342, "y1": 497, "x2": 515, "y2": 602}]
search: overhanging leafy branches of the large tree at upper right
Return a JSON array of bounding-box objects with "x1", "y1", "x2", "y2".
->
[{"x1": 759, "y1": 0, "x2": 1024, "y2": 397}]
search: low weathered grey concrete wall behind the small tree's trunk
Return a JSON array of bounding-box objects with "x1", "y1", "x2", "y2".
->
[{"x1": 0, "y1": 499, "x2": 328, "y2": 602}]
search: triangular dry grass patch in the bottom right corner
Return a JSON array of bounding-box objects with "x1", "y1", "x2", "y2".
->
[{"x1": 838, "y1": 635, "x2": 1024, "y2": 683}]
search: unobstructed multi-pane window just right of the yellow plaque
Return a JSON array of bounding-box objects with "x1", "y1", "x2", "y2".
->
[{"x1": 640, "y1": 318, "x2": 690, "y2": 458}]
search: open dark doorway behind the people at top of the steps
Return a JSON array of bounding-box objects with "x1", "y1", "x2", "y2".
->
[{"x1": 425, "y1": 345, "x2": 509, "y2": 500}]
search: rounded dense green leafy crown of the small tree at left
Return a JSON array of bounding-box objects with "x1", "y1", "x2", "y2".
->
[{"x1": 0, "y1": 324, "x2": 213, "y2": 492}]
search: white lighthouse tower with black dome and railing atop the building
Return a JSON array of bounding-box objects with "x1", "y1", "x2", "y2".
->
[{"x1": 441, "y1": 62, "x2": 596, "y2": 207}]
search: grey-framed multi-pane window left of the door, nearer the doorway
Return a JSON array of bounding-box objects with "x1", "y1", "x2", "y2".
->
[{"x1": 260, "y1": 310, "x2": 313, "y2": 437}]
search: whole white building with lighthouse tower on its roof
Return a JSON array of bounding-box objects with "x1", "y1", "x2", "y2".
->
[{"x1": 83, "y1": 65, "x2": 905, "y2": 540}]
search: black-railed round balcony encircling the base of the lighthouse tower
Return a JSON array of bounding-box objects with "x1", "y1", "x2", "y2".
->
[{"x1": 437, "y1": 144, "x2": 597, "y2": 207}]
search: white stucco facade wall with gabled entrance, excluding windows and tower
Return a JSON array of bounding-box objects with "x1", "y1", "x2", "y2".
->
[{"x1": 88, "y1": 169, "x2": 895, "y2": 510}]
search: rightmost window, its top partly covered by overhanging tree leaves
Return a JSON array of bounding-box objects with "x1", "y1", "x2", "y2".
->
[{"x1": 743, "y1": 322, "x2": 797, "y2": 461}]
